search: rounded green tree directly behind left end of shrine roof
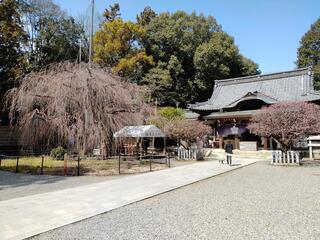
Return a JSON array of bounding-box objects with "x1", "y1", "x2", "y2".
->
[{"x1": 194, "y1": 32, "x2": 259, "y2": 101}]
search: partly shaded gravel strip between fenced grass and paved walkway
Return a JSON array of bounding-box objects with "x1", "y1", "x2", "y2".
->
[{"x1": 0, "y1": 171, "x2": 123, "y2": 201}]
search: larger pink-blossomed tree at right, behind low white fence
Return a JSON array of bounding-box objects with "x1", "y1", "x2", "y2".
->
[{"x1": 248, "y1": 102, "x2": 320, "y2": 151}]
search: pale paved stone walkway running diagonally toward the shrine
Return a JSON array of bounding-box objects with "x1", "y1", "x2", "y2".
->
[{"x1": 0, "y1": 159, "x2": 256, "y2": 240}]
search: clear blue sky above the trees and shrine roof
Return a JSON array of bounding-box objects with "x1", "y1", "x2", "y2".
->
[{"x1": 55, "y1": 0, "x2": 320, "y2": 73}]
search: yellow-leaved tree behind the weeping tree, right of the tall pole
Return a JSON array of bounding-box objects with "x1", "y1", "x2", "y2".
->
[{"x1": 93, "y1": 18, "x2": 153, "y2": 83}]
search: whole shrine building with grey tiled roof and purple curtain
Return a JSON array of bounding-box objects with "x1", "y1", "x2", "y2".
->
[{"x1": 189, "y1": 68, "x2": 320, "y2": 150}]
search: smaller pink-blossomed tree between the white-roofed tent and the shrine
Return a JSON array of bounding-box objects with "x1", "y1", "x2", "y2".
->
[{"x1": 164, "y1": 119, "x2": 212, "y2": 148}]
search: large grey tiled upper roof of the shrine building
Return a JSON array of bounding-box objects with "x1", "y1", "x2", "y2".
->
[{"x1": 189, "y1": 68, "x2": 320, "y2": 111}]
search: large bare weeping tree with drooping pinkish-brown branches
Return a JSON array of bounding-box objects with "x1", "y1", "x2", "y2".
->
[{"x1": 6, "y1": 63, "x2": 150, "y2": 154}]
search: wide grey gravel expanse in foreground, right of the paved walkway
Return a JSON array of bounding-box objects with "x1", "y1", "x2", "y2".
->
[{"x1": 34, "y1": 162, "x2": 320, "y2": 240}]
